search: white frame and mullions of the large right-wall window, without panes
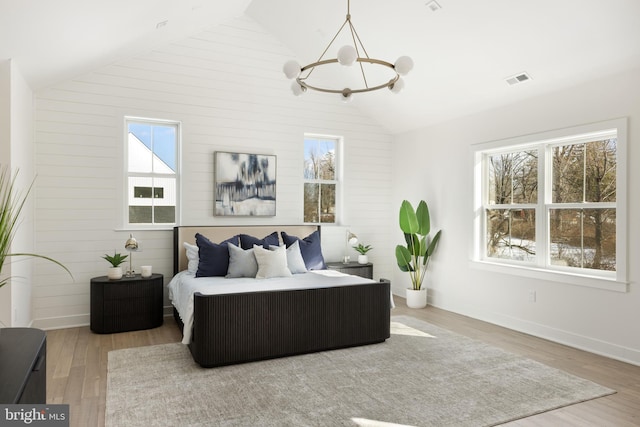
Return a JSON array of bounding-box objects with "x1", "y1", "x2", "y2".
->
[{"x1": 471, "y1": 118, "x2": 628, "y2": 292}]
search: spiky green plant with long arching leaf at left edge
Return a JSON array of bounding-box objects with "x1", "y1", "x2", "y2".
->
[{"x1": 0, "y1": 167, "x2": 73, "y2": 287}]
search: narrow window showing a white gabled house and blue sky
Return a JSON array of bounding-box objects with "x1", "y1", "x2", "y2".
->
[{"x1": 126, "y1": 118, "x2": 180, "y2": 226}]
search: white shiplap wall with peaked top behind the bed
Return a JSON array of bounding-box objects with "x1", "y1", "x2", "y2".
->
[{"x1": 33, "y1": 17, "x2": 393, "y2": 328}]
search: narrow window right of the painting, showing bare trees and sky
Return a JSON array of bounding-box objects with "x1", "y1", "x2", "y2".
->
[{"x1": 303, "y1": 135, "x2": 340, "y2": 223}]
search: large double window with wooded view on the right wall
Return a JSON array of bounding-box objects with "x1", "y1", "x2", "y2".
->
[{"x1": 475, "y1": 120, "x2": 626, "y2": 290}]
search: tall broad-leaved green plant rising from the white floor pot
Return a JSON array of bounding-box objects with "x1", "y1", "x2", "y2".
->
[{"x1": 396, "y1": 200, "x2": 442, "y2": 291}]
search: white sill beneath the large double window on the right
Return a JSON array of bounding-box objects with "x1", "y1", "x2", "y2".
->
[{"x1": 470, "y1": 261, "x2": 629, "y2": 293}]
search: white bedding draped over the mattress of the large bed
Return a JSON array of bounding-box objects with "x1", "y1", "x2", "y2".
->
[{"x1": 167, "y1": 270, "x2": 377, "y2": 344}]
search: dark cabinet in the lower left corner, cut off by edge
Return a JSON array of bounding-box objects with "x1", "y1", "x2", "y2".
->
[{"x1": 0, "y1": 328, "x2": 47, "y2": 404}]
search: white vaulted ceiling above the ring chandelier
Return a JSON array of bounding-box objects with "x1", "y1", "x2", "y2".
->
[{"x1": 0, "y1": 0, "x2": 640, "y2": 132}]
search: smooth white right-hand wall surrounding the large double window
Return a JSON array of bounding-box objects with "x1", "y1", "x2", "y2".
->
[{"x1": 392, "y1": 69, "x2": 640, "y2": 364}]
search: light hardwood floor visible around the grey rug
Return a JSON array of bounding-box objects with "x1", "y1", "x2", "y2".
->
[{"x1": 47, "y1": 297, "x2": 640, "y2": 427}]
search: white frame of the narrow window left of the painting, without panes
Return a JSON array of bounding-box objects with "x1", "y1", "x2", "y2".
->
[{"x1": 122, "y1": 116, "x2": 182, "y2": 230}]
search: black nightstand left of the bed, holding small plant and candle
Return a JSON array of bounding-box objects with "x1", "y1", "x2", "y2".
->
[{"x1": 91, "y1": 274, "x2": 164, "y2": 334}]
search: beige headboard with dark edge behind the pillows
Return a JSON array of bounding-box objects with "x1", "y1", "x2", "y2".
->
[{"x1": 173, "y1": 225, "x2": 320, "y2": 274}]
